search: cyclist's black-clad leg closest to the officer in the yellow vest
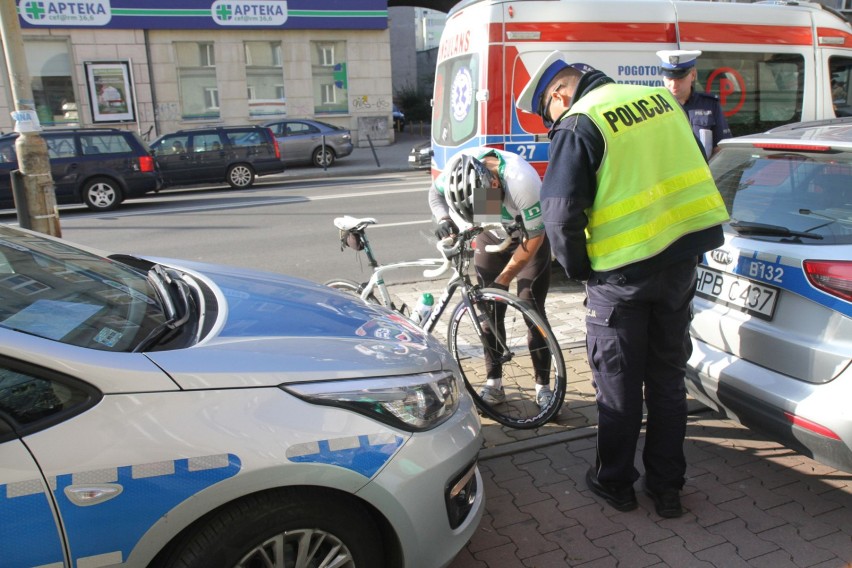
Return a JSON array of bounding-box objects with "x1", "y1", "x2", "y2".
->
[{"x1": 517, "y1": 237, "x2": 551, "y2": 385}]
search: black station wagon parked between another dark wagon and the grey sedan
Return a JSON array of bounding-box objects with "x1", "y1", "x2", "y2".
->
[{"x1": 151, "y1": 125, "x2": 284, "y2": 189}]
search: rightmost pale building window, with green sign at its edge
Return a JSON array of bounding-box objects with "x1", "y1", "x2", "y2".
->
[{"x1": 311, "y1": 41, "x2": 349, "y2": 114}]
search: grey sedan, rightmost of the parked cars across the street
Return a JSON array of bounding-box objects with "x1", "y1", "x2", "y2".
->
[{"x1": 264, "y1": 118, "x2": 352, "y2": 168}]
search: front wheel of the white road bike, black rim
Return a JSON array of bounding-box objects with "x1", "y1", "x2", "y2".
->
[{"x1": 447, "y1": 288, "x2": 567, "y2": 429}]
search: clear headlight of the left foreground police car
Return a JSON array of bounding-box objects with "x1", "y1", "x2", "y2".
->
[{"x1": 280, "y1": 371, "x2": 460, "y2": 432}]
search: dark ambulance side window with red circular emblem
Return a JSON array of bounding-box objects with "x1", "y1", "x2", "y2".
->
[{"x1": 697, "y1": 51, "x2": 805, "y2": 136}]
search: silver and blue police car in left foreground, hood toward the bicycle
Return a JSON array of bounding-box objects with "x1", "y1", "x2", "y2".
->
[{"x1": 0, "y1": 225, "x2": 484, "y2": 568}]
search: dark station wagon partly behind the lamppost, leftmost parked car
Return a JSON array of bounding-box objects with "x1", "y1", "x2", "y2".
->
[{"x1": 0, "y1": 128, "x2": 161, "y2": 211}]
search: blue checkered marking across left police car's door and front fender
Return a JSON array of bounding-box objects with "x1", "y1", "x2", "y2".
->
[{"x1": 0, "y1": 454, "x2": 242, "y2": 568}]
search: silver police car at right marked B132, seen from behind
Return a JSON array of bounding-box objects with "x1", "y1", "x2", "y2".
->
[{"x1": 687, "y1": 119, "x2": 852, "y2": 472}]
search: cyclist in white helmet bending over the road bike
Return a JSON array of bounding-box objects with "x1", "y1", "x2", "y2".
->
[{"x1": 429, "y1": 147, "x2": 553, "y2": 409}]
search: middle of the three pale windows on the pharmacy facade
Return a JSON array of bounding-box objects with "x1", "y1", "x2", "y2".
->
[{"x1": 244, "y1": 41, "x2": 287, "y2": 118}]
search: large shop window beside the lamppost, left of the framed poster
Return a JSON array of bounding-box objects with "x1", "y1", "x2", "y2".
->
[{"x1": 24, "y1": 39, "x2": 79, "y2": 127}]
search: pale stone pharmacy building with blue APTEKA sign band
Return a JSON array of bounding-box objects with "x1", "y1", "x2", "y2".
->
[{"x1": 0, "y1": 0, "x2": 393, "y2": 145}]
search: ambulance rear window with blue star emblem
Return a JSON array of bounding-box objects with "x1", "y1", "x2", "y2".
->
[{"x1": 432, "y1": 54, "x2": 479, "y2": 146}]
